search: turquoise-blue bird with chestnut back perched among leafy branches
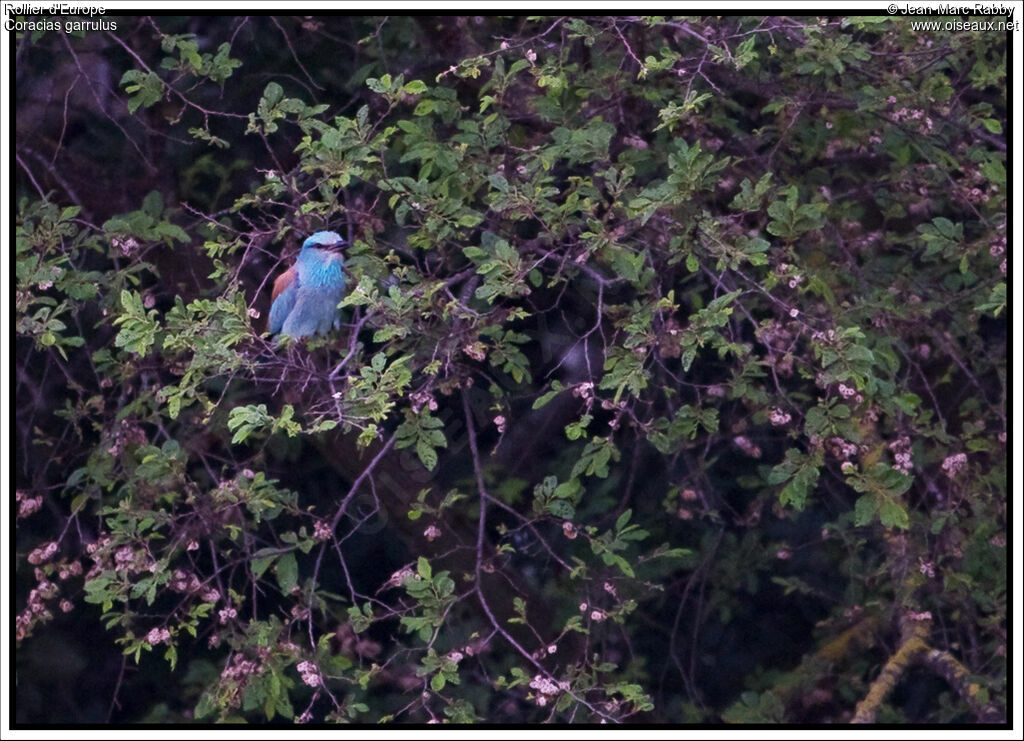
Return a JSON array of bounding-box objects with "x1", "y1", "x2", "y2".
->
[{"x1": 267, "y1": 231, "x2": 345, "y2": 339}]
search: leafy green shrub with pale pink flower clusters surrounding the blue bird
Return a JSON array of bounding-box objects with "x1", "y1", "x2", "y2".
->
[{"x1": 14, "y1": 16, "x2": 1008, "y2": 724}]
